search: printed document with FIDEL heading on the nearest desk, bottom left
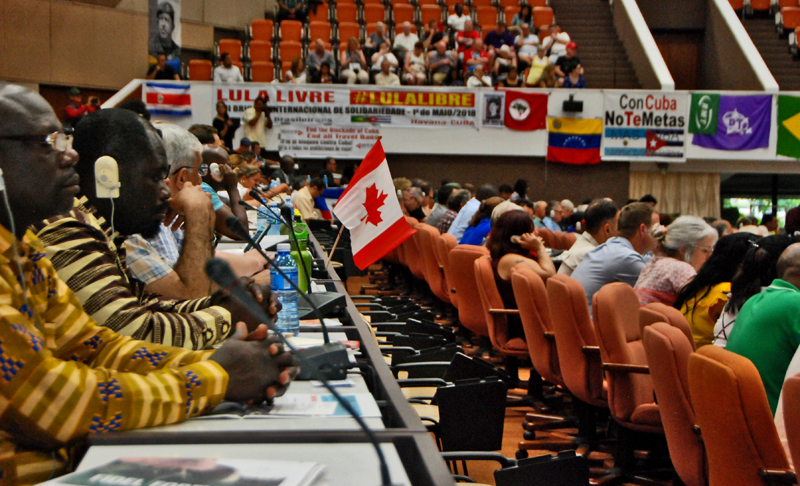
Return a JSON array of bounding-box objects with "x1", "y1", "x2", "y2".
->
[{"x1": 42, "y1": 457, "x2": 325, "y2": 486}]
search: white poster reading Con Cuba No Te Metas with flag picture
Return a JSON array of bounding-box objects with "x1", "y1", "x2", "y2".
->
[{"x1": 601, "y1": 91, "x2": 689, "y2": 162}]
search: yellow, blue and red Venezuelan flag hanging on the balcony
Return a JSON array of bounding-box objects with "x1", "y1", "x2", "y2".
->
[{"x1": 547, "y1": 117, "x2": 603, "y2": 164}]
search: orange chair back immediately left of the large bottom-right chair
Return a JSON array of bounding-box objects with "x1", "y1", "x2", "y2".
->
[{"x1": 642, "y1": 322, "x2": 708, "y2": 486}]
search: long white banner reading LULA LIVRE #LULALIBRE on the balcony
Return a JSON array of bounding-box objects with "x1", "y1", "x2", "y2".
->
[{"x1": 211, "y1": 83, "x2": 481, "y2": 130}]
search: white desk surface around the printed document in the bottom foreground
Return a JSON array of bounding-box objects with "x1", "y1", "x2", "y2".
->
[{"x1": 78, "y1": 444, "x2": 411, "y2": 486}]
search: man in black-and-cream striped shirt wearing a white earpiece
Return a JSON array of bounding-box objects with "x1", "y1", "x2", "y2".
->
[{"x1": 36, "y1": 110, "x2": 277, "y2": 349}]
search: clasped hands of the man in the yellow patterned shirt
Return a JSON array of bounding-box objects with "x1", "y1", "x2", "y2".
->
[{"x1": 208, "y1": 322, "x2": 300, "y2": 402}]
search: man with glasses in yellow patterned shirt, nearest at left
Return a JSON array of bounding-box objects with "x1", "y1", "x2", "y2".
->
[{"x1": 0, "y1": 83, "x2": 296, "y2": 486}]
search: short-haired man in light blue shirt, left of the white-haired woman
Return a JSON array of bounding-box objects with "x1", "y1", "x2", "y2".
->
[{"x1": 572, "y1": 203, "x2": 656, "y2": 312}]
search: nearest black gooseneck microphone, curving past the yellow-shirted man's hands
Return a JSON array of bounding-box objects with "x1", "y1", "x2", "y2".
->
[{"x1": 206, "y1": 258, "x2": 392, "y2": 486}]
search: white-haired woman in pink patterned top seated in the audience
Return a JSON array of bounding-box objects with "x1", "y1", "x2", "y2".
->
[{"x1": 633, "y1": 216, "x2": 718, "y2": 306}]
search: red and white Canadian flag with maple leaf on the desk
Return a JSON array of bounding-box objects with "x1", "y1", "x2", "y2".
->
[{"x1": 333, "y1": 140, "x2": 416, "y2": 270}]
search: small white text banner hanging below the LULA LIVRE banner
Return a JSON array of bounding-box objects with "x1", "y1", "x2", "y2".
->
[{"x1": 278, "y1": 126, "x2": 380, "y2": 159}]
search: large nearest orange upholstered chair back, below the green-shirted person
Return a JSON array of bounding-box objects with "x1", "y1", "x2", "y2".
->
[{"x1": 689, "y1": 346, "x2": 797, "y2": 486}]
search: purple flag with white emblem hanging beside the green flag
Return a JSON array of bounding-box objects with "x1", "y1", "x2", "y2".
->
[{"x1": 691, "y1": 95, "x2": 772, "y2": 150}]
